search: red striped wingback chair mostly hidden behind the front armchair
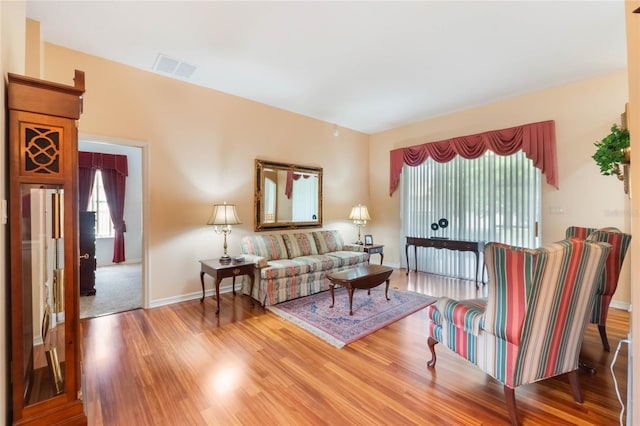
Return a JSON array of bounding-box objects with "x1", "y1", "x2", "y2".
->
[{"x1": 566, "y1": 226, "x2": 631, "y2": 352}]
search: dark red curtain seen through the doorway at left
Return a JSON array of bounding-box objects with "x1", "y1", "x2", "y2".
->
[{"x1": 78, "y1": 152, "x2": 129, "y2": 263}]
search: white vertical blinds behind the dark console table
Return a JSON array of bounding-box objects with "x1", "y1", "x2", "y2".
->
[{"x1": 400, "y1": 151, "x2": 541, "y2": 280}]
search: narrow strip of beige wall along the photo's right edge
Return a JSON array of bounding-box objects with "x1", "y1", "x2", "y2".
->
[{"x1": 626, "y1": 0, "x2": 640, "y2": 425}]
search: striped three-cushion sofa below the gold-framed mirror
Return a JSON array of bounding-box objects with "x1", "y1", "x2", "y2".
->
[{"x1": 240, "y1": 231, "x2": 369, "y2": 306}]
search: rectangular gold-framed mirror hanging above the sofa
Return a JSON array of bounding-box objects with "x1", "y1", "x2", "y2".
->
[{"x1": 254, "y1": 159, "x2": 322, "y2": 231}]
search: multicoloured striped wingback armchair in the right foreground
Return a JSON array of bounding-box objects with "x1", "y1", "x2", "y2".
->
[{"x1": 427, "y1": 239, "x2": 610, "y2": 424}]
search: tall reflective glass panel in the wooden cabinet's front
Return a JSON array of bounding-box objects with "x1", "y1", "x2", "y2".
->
[{"x1": 21, "y1": 185, "x2": 65, "y2": 405}]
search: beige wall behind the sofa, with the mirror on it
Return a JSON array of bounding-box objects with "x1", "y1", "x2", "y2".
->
[{"x1": 43, "y1": 43, "x2": 369, "y2": 305}]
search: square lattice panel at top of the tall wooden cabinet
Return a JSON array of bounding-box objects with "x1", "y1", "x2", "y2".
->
[{"x1": 24, "y1": 127, "x2": 62, "y2": 174}]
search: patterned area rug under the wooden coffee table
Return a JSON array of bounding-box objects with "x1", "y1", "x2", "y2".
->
[{"x1": 267, "y1": 285, "x2": 436, "y2": 348}]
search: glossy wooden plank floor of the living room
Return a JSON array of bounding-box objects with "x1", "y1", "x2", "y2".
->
[{"x1": 81, "y1": 270, "x2": 629, "y2": 426}]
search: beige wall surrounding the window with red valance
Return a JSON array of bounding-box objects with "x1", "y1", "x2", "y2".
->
[{"x1": 368, "y1": 71, "x2": 630, "y2": 306}]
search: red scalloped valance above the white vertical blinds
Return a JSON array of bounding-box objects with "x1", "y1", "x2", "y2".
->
[{"x1": 389, "y1": 120, "x2": 559, "y2": 196}]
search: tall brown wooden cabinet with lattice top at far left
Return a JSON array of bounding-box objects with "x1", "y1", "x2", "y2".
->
[{"x1": 7, "y1": 71, "x2": 87, "y2": 425}]
